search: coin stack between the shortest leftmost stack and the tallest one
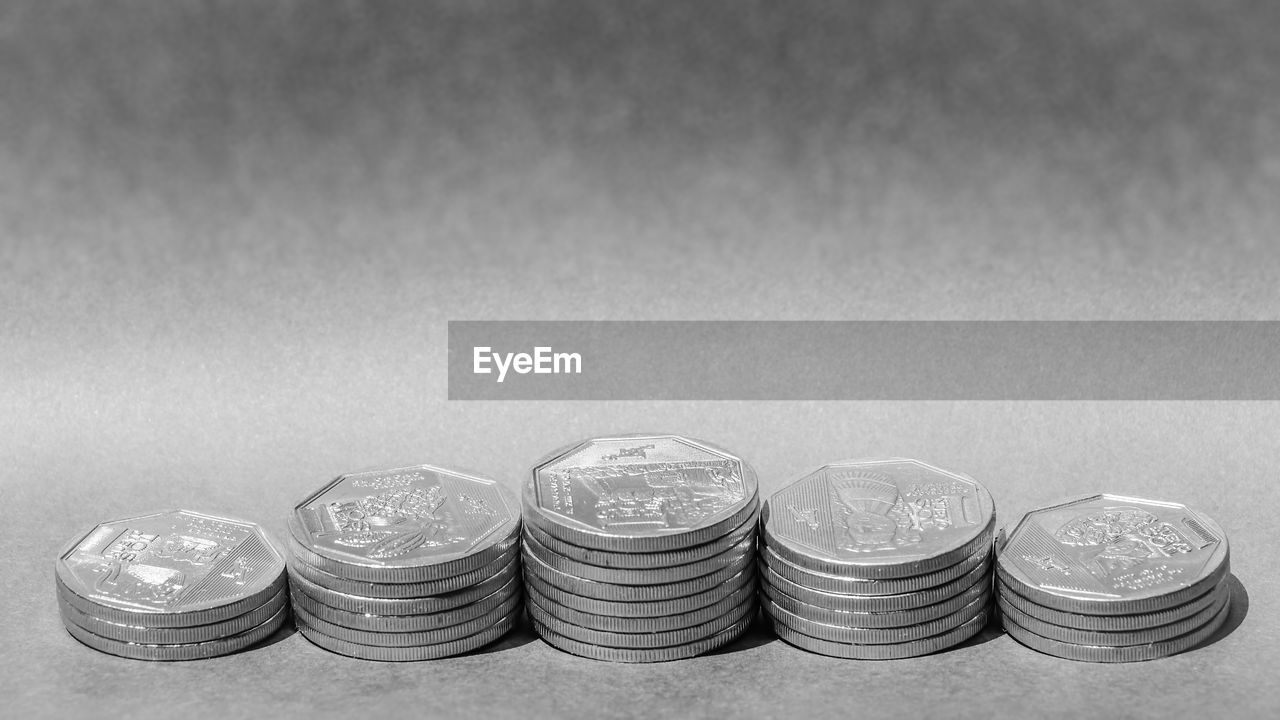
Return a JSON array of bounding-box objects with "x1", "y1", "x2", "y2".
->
[{"x1": 289, "y1": 465, "x2": 521, "y2": 661}]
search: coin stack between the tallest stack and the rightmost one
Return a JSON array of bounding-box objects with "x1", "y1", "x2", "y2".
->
[{"x1": 760, "y1": 459, "x2": 996, "y2": 660}]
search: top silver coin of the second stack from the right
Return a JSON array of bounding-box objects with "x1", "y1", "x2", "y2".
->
[{"x1": 762, "y1": 457, "x2": 996, "y2": 579}]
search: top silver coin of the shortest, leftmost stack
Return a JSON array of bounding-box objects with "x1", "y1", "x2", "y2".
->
[{"x1": 55, "y1": 510, "x2": 284, "y2": 628}]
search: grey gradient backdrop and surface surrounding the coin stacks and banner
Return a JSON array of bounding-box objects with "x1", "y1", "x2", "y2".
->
[{"x1": 0, "y1": 1, "x2": 1280, "y2": 717}]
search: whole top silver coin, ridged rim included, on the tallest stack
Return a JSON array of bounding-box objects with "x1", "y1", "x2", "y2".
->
[{"x1": 522, "y1": 434, "x2": 759, "y2": 552}]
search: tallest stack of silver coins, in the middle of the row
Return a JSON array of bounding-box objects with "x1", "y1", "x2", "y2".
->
[{"x1": 522, "y1": 436, "x2": 759, "y2": 662}]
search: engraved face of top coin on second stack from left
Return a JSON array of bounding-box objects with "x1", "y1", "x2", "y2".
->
[{"x1": 291, "y1": 465, "x2": 518, "y2": 565}]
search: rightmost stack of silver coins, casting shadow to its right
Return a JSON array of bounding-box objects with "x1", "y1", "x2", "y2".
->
[{"x1": 996, "y1": 495, "x2": 1230, "y2": 662}]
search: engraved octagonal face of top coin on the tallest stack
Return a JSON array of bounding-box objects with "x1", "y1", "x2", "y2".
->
[{"x1": 534, "y1": 436, "x2": 755, "y2": 534}]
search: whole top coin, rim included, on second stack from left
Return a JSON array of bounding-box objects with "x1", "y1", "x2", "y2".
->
[{"x1": 289, "y1": 465, "x2": 520, "y2": 584}]
